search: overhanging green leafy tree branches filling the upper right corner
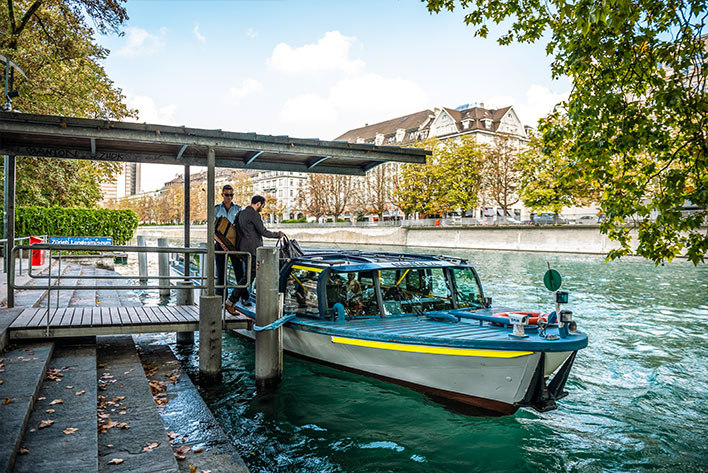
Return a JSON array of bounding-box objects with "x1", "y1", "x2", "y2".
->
[{"x1": 426, "y1": 0, "x2": 708, "y2": 264}]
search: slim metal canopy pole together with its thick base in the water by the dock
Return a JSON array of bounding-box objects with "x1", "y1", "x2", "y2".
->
[{"x1": 199, "y1": 148, "x2": 222, "y2": 378}]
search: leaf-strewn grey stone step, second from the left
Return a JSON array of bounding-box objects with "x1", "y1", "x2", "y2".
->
[{"x1": 13, "y1": 342, "x2": 98, "y2": 473}]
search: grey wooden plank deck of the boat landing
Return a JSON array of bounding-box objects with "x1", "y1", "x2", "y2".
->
[{"x1": 9, "y1": 305, "x2": 251, "y2": 340}]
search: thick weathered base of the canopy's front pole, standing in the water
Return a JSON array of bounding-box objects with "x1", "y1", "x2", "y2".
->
[{"x1": 199, "y1": 296, "x2": 221, "y2": 377}]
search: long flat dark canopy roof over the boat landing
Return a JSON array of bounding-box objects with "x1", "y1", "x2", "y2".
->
[{"x1": 0, "y1": 112, "x2": 431, "y2": 175}]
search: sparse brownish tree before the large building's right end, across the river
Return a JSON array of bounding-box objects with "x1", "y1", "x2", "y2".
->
[{"x1": 482, "y1": 136, "x2": 520, "y2": 215}]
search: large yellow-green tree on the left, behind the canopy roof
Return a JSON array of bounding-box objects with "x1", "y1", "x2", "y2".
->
[{"x1": 0, "y1": 0, "x2": 136, "y2": 206}]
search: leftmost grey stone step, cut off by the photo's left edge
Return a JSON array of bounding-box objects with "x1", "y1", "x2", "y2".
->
[{"x1": 0, "y1": 342, "x2": 54, "y2": 472}]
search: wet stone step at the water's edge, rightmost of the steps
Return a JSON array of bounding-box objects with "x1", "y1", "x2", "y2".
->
[{"x1": 135, "y1": 334, "x2": 249, "y2": 473}]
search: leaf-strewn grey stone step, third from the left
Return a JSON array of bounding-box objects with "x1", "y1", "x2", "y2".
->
[{"x1": 97, "y1": 336, "x2": 178, "y2": 473}]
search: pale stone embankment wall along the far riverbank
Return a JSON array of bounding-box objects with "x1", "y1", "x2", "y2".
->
[{"x1": 137, "y1": 225, "x2": 632, "y2": 254}]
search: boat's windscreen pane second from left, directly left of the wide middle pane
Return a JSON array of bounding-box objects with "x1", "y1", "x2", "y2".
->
[{"x1": 327, "y1": 271, "x2": 380, "y2": 319}]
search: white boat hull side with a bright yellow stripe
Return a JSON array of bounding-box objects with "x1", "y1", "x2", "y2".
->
[{"x1": 237, "y1": 327, "x2": 571, "y2": 414}]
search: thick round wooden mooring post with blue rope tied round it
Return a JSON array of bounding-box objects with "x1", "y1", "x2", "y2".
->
[{"x1": 256, "y1": 247, "x2": 283, "y2": 388}]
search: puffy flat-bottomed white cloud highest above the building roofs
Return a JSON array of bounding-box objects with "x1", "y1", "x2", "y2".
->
[{"x1": 266, "y1": 31, "x2": 364, "y2": 74}]
